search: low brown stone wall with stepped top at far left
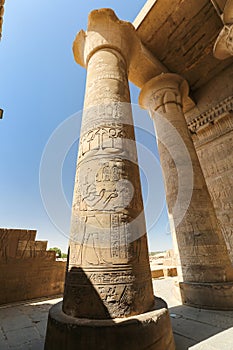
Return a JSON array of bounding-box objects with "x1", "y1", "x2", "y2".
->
[{"x1": 0, "y1": 228, "x2": 66, "y2": 304}]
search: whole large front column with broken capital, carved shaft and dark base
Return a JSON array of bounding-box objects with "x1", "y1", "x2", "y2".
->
[{"x1": 45, "y1": 9, "x2": 174, "y2": 350}]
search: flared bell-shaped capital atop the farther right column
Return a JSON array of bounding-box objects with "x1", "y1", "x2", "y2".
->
[{"x1": 139, "y1": 73, "x2": 189, "y2": 112}]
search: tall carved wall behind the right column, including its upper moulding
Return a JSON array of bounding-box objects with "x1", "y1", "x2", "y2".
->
[{"x1": 193, "y1": 113, "x2": 233, "y2": 263}]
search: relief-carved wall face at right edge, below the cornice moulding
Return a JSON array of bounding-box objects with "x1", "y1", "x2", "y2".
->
[{"x1": 197, "y1": 130, "x2": 233, "y2": 262}]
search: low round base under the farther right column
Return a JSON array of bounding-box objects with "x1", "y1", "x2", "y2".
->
[{"x1": 178, "y1": 282, "x2": 233, "y2": 310}]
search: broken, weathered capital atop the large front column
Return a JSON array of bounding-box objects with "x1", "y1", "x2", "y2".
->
[{"x1": 73, "y1": 8, "x2": 140, "y2": 67}]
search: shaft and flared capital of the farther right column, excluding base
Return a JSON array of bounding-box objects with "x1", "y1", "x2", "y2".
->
[{"x1": 140, "y1": 73, "x2": 232, "y2": 282}]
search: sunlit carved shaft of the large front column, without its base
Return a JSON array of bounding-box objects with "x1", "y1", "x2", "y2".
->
[{"x1": 63, "y1": 12, "x2": 154, "y2": 319}]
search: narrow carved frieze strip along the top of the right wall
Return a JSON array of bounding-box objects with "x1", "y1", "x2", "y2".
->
[{"x1": 188, "y1": 96, "x2": 233, "y2": 133}]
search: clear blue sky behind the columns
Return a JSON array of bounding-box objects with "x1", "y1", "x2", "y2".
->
[{"x1": 0, "y1": 0, "x2": 172, "y2": 252}]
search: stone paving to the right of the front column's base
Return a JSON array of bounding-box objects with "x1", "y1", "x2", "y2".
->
[{"x1": 153, "y1": 277, "x2": 233, "y2": 350}]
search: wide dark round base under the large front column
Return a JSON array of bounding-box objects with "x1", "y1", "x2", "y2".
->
[{"x1": 44, "y1": 298, "x2": 175, "y2": 350}]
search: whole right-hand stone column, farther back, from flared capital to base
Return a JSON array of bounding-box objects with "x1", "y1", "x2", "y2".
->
[{"x1": 139, "y1": 73, "x2": 233, "y2": 309}]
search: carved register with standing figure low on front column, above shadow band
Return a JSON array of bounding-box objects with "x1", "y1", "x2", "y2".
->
[{"x1": 70, "y1": 213, "x2": 133, "y2": 265}]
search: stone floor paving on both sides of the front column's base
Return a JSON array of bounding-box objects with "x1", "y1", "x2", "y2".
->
[{"x1": 0, "y1": 277, "x2": 233, "y2": 350}]
